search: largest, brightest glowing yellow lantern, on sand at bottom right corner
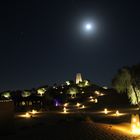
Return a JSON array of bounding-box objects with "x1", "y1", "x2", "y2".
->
[{"x1": 131, "y1": 114, "x2": 140, "y2": 134}]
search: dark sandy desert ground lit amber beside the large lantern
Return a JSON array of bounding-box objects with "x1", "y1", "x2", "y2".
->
[{"x1": 0, "y1": 106, "x2": 140, "y2": 140}]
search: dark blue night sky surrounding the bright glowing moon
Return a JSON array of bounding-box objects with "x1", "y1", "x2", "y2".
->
[{"x1": 0, "y1": 0, "x2": 140, "y2": 91}]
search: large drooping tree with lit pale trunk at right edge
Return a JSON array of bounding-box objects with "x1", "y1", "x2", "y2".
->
[{"x1": 112, "y1": 65, "x2": 140, "y2": 108}]
